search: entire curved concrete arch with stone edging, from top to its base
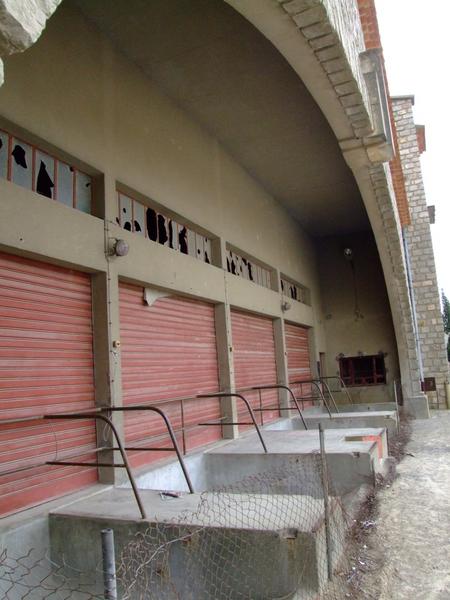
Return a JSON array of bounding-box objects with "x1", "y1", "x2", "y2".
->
[{"x1": 225, "y1": 0, "x2": 428, "y2": 417}]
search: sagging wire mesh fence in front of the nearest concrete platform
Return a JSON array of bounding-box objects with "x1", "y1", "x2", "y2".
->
[{"x1": 0, "y1": 453, "x2": 376, "y2": 600}]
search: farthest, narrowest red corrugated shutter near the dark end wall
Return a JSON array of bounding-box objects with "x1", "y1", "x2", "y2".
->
[{"x1": 284, "y1": 323, "x2": 311, "y2": 406}]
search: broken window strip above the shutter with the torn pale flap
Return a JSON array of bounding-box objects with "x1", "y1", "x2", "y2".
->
[{"x1": 116, "y1": 192, "x2": 211, "y2": 264}]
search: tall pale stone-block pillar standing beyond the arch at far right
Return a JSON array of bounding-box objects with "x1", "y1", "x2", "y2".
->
[{"x1": 392, "y1": 96, "x2": 448, "y2": 406}]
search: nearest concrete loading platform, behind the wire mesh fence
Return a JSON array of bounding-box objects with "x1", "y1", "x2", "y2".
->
[{"x1": 49, "y1": 488, "x2": 347, "y2": 600}]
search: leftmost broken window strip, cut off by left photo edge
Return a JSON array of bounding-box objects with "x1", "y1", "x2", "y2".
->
[{"x1": 0, "y1": 131, "x2": 92, "y2": 213}]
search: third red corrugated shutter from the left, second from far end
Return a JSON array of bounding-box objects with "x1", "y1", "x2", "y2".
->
[{"x1": 231, "y1": 310, "x2": 280, "y2": 429}]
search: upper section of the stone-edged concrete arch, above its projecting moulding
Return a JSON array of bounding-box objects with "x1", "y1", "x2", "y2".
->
[{"x1": 226, "y1": 0, "x2": 392, "y2": 165}]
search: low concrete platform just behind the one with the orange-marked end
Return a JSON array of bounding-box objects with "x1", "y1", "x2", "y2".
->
[{"x1": 265, "y1": 407, "x2": 398, "y2": 437}]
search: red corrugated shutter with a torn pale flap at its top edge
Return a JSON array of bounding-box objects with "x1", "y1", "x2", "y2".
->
[{"x1": 120, "y1": 283, "x2": 221, "y2": 466}]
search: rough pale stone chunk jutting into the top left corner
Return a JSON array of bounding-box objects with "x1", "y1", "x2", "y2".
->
[{"x1": 0, "y1": 0, "x2": 62, "y2": 85}]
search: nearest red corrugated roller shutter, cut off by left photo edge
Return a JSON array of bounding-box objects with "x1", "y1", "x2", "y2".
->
[{"x1": 0, "y1": 253, "x2": 97, "y2": 515}]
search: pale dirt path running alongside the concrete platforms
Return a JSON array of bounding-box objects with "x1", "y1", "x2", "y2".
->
[{"x1": 352, "y1": 411, "x2": 450, "y2": 600}]
